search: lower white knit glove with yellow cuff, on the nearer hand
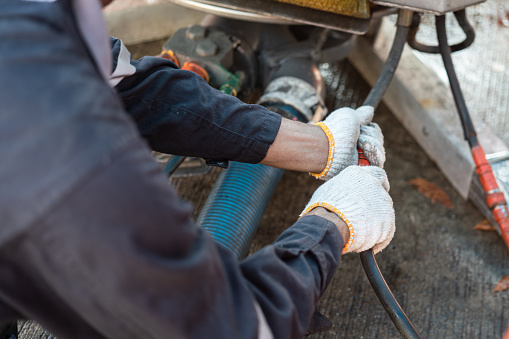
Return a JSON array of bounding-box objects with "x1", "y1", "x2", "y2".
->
[{"x1": 301, "y1": 166, "x2": 395, "y2": 253}]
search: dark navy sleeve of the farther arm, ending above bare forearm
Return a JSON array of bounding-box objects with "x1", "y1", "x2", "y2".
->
[{"x1": 110, "y1": 39, "x2": 281, "y2": 163}]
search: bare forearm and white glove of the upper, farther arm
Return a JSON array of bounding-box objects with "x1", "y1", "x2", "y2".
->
[{"x1": 261, "y1": 106, "x2": 385, "y2": 180}]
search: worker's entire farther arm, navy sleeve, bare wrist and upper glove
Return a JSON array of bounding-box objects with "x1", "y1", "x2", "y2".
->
[{"x1": 111, "y1": 39, "x2": 384, "y2": 175}]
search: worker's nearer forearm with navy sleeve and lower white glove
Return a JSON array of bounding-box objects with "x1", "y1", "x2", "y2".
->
[{"x1": 242, "y1": 166, "x2": 395, "y2": 338}]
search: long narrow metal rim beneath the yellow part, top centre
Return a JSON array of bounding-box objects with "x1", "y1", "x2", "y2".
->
[{"x1": 168, "y1": 0, "x2": 370, "y2": 34}]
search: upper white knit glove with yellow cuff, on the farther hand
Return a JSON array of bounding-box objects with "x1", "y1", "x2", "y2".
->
[{"x1": 311, "y1": 106, "x2": 385, "y2": 180}]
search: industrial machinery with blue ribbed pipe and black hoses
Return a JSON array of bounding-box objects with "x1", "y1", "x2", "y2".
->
[{"x1": 5, "y1": 0, "x2": 509, "y2": 338}]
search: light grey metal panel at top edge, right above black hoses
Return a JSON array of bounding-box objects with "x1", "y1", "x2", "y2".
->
[{"x1": 372, "y1": 0, "x2": 486, "y2": 14}]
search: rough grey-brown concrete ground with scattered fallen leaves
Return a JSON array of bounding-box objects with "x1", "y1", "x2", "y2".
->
[{"x1": 10, "y1": 0, "x2": 509, "y2": 339}]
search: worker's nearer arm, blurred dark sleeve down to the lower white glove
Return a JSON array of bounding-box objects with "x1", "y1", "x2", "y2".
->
[{"x1": 0, "y1": 145, "x2": 392, "y2": 339}]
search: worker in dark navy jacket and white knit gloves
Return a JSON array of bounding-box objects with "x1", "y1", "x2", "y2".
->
[{"x1": 0, "y1": 0, "x2": 394, "y2": 339}]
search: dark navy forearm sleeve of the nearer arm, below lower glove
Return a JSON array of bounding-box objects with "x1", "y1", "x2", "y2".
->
[{"x1": 241, "y1": 216, "x2": 343, "y2": 338}]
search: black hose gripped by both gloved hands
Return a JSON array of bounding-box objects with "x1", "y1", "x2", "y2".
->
[{"x1": 360, "y1": 21, "x2": 420, "y2": 338}]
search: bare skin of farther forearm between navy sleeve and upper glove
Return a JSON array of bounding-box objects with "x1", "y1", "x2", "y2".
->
[{"x1": 261, "y1": 119, "x2": 329, "y2": 173}]
